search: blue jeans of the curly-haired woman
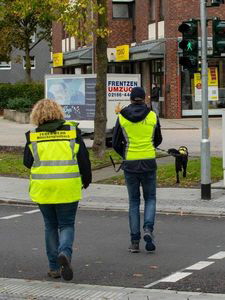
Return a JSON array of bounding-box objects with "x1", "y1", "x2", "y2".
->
[{"x1": 39, "y1": 202, "x2": 78, "y2": 271}]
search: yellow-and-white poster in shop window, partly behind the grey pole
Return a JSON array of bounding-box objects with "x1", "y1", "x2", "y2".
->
[{"x1": 194, "y1": 67, "x2": 219, "y2": 101}]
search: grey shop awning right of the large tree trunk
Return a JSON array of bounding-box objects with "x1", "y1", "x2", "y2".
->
[{"x1": 130, "y1": 39, "x2": 165, "y2": 61}]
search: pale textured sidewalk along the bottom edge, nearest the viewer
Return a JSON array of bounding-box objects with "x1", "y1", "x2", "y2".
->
[{"x1": 0, "y1": 278, "x2": 225, "y2": 300}]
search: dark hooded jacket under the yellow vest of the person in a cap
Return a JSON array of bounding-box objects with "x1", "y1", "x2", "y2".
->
[{"x1": 112, "y1": 103, "x2": 162, "y2": 173}]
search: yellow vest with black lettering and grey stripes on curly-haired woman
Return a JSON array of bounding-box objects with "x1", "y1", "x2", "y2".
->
[{"x1": 29, "y1": 122, "x2": 82, "y2": 204}]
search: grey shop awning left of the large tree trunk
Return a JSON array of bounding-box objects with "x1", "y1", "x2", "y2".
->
[{"x1": 63, "y1": 47, "x2": 92, "y2": 67}]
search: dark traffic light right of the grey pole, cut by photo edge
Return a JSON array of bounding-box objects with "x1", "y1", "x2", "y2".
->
[{"x1": 213, "y1": 19, "x2": 225, "y2": 56}]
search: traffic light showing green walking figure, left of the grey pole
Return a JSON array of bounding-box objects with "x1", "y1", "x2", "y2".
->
[{"x1": 178, "y1": 20, "x2": 198, "y2": 72}]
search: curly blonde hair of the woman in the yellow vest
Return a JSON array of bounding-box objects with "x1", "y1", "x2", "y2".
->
[{"x1": 30, "y1": 99, "x2": 64, "y2": 126}]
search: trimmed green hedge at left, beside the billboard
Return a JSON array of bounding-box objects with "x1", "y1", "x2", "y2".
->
[{"x1": 0, "y1": 83, "x2": 44, "y2": 109}]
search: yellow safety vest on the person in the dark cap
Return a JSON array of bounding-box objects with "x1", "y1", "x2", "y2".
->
[{"x1": 119, "y1": 111, "x2": 157, "y2": 160}]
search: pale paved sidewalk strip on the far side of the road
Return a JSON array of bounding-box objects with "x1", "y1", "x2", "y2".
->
[{"x1": 0, "y1": 177, "x2": 225, "y2": 216}]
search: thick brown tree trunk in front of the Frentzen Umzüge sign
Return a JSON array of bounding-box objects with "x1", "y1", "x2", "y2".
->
[{"x1": 92, "y1": 0, "x2": 108, "y2": 157}]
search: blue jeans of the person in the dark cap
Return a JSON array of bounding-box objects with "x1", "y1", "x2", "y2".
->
[{"x1": 124, "y1": 170, "x2": 156, "y2": 241}]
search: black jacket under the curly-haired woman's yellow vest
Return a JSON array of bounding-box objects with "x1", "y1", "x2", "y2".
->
[{"x1": 23, "y1": 120, "x2": 92, "y2": 189}]
